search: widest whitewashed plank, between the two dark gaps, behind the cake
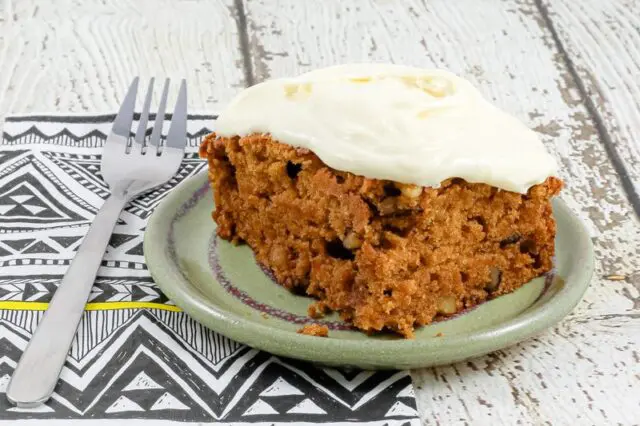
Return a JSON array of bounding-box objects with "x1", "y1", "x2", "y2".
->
[{"x1": 244, "y1": 0, "x2": 640, "y2": 425}]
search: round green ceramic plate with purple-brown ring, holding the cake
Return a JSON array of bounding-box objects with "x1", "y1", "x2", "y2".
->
[{"x1": 144, "y1": 173, "x2": 593, "y2": 369}]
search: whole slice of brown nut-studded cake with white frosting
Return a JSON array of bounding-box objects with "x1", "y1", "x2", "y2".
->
[{"x1": 200, "y1": 64, "x2": 562, "y2": 338}]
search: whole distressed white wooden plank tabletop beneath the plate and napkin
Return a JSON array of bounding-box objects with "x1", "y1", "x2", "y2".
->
[{"x1": 0, "y1": 0, "x2": 640, "y2": 425}]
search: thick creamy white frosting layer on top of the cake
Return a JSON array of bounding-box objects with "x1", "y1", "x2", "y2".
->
[{"x1": 216, "y1": 64, "x2": 556, "y2": 193}]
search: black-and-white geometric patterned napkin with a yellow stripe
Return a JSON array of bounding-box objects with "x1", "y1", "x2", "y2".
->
[{"x1": 0, "y1": 115, "x2": 420, "y2": 425}]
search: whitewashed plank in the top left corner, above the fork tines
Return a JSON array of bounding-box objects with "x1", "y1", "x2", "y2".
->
[{"x1": 0, "y1": 0, "x2": 244, "y2": 118}]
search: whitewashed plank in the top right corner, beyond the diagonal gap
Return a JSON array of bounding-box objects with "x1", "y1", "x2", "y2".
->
[{"x1": 542, "y1": 0, "x2": 640, "y2": 215}]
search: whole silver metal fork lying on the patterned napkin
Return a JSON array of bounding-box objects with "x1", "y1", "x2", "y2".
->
[{"x1": 6, "y1": 77, "x2": 187, "y2": 408}]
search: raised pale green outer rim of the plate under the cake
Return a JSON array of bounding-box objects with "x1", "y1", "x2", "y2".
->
[{"x1": 143, "y1": 169, "x2": 594, "y2": 369}]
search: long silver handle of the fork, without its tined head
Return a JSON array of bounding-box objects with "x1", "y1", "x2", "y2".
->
[{"x1": 7, "y1": 194, "x2": 127, "y2": 407}]
